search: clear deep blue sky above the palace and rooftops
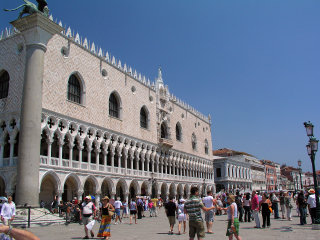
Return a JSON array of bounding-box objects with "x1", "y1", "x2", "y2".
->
[{"x1": 0, "y1": 0, "x2": 320, "y2": 171}]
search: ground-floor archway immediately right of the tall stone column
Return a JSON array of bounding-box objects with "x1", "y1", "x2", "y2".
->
[{"x1": 39, "y1": 174, "x2": 58, "y2": 204}]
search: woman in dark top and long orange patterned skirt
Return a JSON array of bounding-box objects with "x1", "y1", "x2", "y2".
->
[{"x1": 97, "y1": 196, "x2": 115, "y2": 239}]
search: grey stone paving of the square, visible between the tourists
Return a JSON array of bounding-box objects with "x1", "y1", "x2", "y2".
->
[{"x1": 30, "y1": 209, "x2": 320, "y2": 240}]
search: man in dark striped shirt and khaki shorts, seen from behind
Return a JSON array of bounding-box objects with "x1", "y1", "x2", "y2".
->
[{"x1": 184, "y1": 187, "x2": 215, "y2": 240}]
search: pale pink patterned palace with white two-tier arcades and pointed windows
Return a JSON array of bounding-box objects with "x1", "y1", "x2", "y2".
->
[{"x1": 0, "y1": 18, "x2": 215, "y2": 202}]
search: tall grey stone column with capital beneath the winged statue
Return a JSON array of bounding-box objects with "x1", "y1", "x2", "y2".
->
[{"x1": 12, "y1": 13, "x2": 63, "y2": 206}]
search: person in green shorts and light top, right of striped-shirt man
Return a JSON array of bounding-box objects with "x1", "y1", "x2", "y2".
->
[{"x1": 222, "y1": 195, "x2": 242, "y2": 240}]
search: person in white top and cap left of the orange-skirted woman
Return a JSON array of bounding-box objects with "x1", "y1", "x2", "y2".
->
[{"x1": 80, "y1": 196, "x2": 96, "y2": 239}]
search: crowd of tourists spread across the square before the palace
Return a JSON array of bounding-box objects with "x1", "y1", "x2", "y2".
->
[{"x1": 0, "y1": 187, "x2": 316, "y2": 240}]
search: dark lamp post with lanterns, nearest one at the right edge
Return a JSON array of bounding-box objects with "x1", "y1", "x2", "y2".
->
[{"x1": 304, "y1": 121, "x2": 320, "y2": 230}]
